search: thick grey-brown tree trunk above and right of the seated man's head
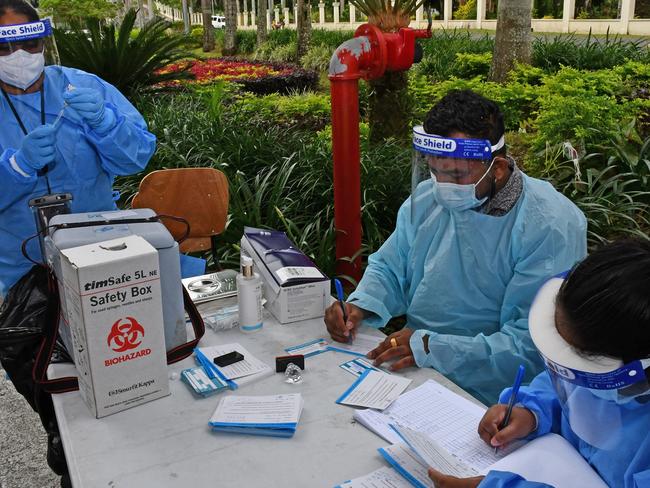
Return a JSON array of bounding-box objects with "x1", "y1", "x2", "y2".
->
[{"x1": 490, "y1": 0, "x2": 533, "y2": 83}]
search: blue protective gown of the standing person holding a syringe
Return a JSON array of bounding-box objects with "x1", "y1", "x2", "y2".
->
[{"x1": 0, "y1": 66, "x2": 156, "y2": 297}]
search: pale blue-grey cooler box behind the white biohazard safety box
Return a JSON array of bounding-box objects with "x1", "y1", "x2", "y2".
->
[{"x1": 45, "y1": 209, "x2": 187, "y2": 357}]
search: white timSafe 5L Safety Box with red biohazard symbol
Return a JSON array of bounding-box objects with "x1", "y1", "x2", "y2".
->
[{"x1": 59, "y1": 236, "x2": 169, "y2": 418}]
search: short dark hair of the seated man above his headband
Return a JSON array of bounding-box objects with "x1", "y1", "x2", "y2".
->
[{"x1": 424, "y1": 90, "x2": 506, "y2": 155}]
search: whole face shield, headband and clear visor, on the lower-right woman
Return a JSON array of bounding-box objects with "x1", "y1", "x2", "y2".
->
[{"x1": 528, "y1": 278, "x2": 650, "y2": 450}]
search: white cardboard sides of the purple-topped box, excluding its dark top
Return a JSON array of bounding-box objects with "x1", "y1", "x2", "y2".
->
[{"x1": 241, "y1": 236, "x2": 330, "y2": 324}]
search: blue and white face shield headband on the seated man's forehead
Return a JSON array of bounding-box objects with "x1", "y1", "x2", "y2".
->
[{"x1": 413, "y1": 125, "x2": 505, "y2": 162}]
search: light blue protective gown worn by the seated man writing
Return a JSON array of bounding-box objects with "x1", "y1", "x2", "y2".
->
[{"x1": 349, "y1": 175, "x2": 587, "y2": 404}]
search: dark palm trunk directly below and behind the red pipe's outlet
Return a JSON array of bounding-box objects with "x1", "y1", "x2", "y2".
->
[{"x1": 368, "y1": 71, "x2": 411, "y2": 144}]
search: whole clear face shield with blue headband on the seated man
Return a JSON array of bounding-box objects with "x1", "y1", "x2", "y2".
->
[{"x1": 411, "y1": 126, "x2": 505, "y2": 221}]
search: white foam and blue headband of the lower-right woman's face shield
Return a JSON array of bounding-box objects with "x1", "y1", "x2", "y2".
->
[{"x1": 529, "y1": 278, "x2": 650, "y2": 395}]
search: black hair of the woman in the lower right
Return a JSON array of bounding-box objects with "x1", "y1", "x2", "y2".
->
[{"x1": 556, "y1": 239, "x2": 650, "y2": 363}]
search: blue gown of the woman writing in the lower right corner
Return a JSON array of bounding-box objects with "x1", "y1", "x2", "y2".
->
[{"x1": 479, "y1": 372, "x2": 650, "y2": 488}]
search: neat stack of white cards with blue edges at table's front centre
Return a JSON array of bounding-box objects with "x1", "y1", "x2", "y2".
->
[{"x1": 209, "y1": 393, "x2": 303, "y2": 437}]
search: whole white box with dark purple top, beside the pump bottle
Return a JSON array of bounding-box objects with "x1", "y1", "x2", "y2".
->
[{"x1": 241, "y1": 227, "x2": 330, "y2": 324}]
